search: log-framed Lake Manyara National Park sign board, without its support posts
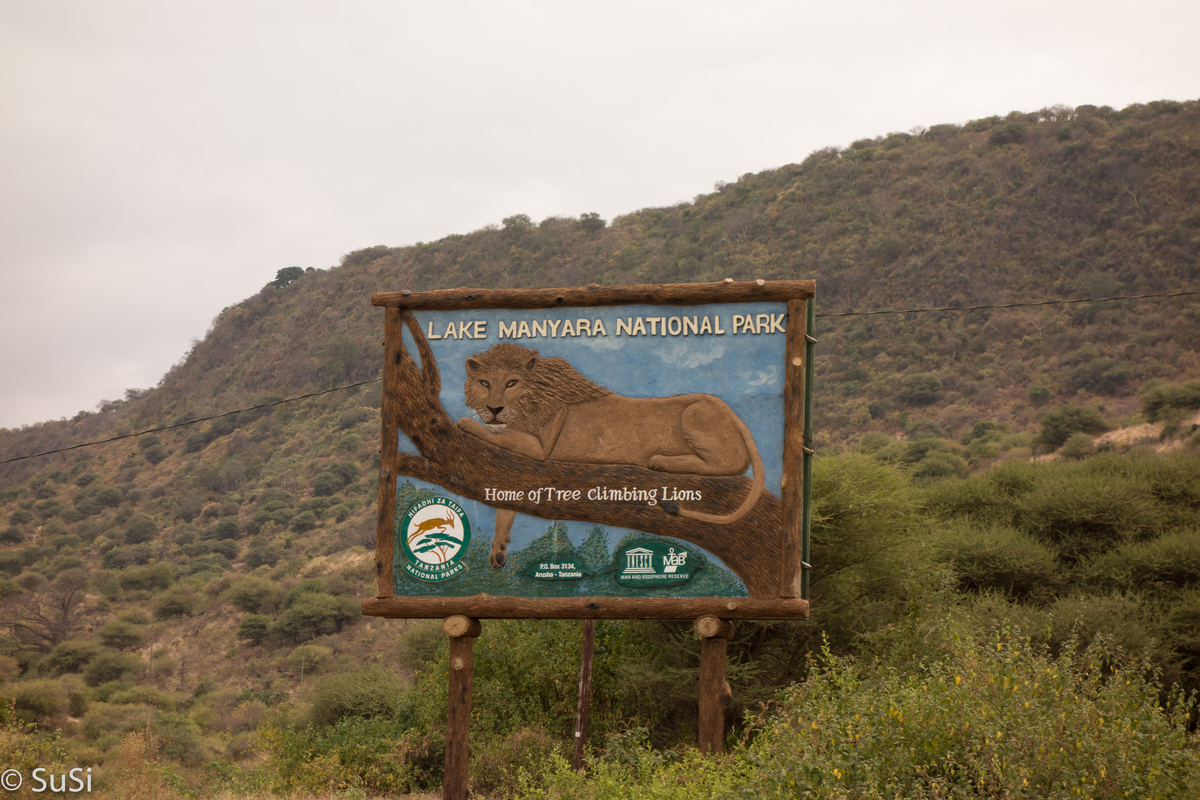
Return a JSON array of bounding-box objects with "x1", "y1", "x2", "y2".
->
[{"x1": 364, "y1": 282, "x2": 814, "y2": 618}]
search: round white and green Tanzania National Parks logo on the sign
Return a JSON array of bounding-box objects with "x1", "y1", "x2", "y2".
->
[{"x1": 398, "y1": 498, "x2": 470, "y2": 582}]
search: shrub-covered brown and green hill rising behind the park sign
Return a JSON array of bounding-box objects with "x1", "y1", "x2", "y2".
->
[{"x1": 0, "y1": 102, "x2": 1200, "y2": 789}]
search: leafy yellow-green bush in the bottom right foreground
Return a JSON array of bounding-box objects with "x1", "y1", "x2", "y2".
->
[{"x1": 517, "y1": 630, "x2": 1200, "y2": 800}]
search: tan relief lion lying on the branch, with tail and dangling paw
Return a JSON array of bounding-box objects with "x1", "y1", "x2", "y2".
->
[{"x1": 458, "y1": 343, "x2": 763, "y2": 569}]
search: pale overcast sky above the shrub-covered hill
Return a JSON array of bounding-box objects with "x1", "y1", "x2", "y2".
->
[{"x1": 0, "y1": 0, "x2": 1200, "y2": 427}]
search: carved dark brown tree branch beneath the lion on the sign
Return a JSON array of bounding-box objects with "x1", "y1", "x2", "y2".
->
[{"x1": 384, "y1": 308, "x2": 784, "y2": 597}]
